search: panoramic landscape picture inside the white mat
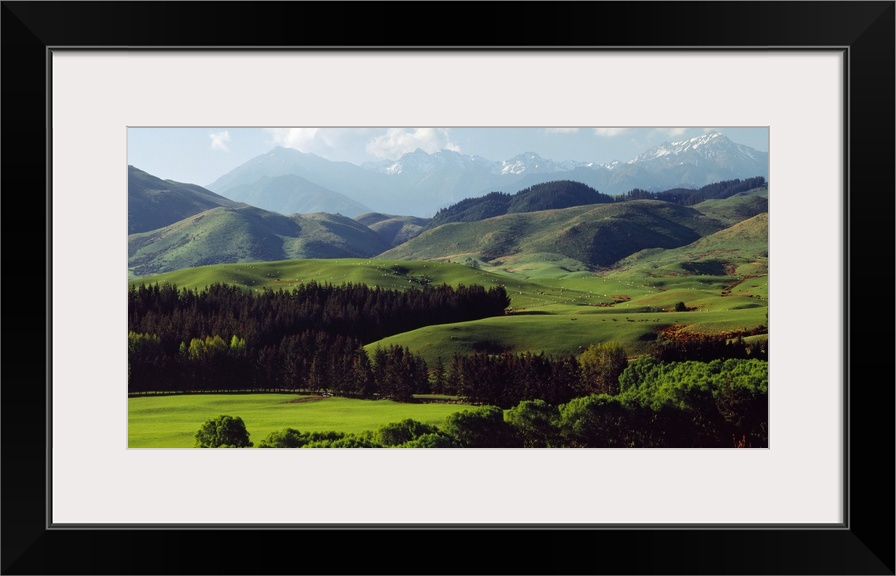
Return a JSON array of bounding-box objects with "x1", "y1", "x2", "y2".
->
[{"x1": 127, "y1": 127, "x2": 769, "y2": 448}]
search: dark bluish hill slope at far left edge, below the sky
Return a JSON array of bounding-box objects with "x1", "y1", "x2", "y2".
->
[{"x1": 128, "y1": 166, "x2": 240, "y2": 234}]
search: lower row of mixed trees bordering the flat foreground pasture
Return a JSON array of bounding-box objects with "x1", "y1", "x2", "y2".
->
[{"x1": 128, "y1": 284, "x2": 767, "y2": 408}]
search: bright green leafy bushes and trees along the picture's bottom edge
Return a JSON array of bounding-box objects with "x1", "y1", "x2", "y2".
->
[{"x1": 219, "y1": 356, "x2": 768, "y2": 448}]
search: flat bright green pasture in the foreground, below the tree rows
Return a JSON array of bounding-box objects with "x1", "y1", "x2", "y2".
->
[{"x1": 128, "y1": 394, "x2": 469, "y2": 448}]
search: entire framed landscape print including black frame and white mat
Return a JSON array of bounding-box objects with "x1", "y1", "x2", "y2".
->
[{"x1": 3, "y1": 2, "x2": 894, "y2": 574}]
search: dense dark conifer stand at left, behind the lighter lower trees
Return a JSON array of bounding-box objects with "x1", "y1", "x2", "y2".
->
[{"x1": 128, "y1": 282, "x2": 510, "y2": 354}]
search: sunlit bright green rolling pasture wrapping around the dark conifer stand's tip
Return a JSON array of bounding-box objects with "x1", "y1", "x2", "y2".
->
[{"x1": 131, "y1": 249, "x2": 768, "y2": 361}]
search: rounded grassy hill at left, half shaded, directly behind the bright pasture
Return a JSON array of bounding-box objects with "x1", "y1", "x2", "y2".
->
[{"x1": 128, "y1": 206, "x2": 388, "y2": 277}]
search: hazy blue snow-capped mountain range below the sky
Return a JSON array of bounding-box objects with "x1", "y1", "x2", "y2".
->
[{"x1": 207, "y1": 132, "x2": 768, "y2": 217}]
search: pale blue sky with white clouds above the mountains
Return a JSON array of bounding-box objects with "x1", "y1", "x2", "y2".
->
[{"x1": 128, "y1": 127, "x2": 768, "y2": 186}]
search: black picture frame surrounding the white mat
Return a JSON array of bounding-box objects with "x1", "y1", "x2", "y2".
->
[{"x1": 0, "y1": 1, "x2": 896, "y2": 574}]
